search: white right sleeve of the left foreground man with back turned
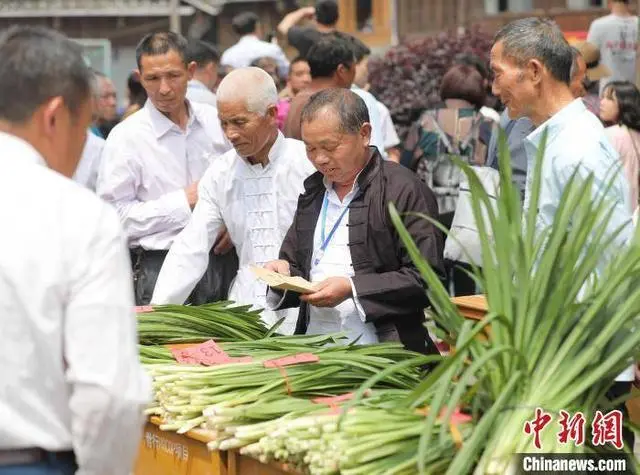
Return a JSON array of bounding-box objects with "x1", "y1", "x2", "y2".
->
[{"x1": 64, "y1": 206, "x2": 151, "y2": 475}]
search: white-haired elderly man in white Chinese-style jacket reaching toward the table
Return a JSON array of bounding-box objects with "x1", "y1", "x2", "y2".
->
[{"x1": 152, "y1": 68, "x2": 315, "y2": 333}]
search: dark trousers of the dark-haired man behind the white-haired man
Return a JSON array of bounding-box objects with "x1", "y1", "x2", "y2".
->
[{"x1": 131, "y1": 248, "x2": 238, "y2": 305}]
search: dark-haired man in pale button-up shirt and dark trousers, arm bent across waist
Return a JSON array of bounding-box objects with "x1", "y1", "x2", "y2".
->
[{"x1": 97, "y1": 33, "x2": 236, "y2": 305}]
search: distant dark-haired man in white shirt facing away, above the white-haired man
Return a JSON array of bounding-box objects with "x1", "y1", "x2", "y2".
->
[{"x1": 220, "y1": 12, "x2": 289, "y2": 78}]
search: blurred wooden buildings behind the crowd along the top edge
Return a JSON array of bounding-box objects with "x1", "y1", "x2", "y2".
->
[{"x1": 0, "y1": 0, "x2": 632, "y2": 106}]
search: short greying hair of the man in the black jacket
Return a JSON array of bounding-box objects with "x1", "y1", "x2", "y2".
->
[{"x1": 300, "y1": 88, "x2": 369, "y2": 135}]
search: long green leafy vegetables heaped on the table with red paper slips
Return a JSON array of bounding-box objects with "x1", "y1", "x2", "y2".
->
[{"x1": 138, "y1": 132, "x2": 640, "y2": 475}]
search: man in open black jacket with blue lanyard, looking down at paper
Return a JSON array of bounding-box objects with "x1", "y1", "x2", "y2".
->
[{"x1": 265, "y1": 89, "x2": 443, "y2": 353}]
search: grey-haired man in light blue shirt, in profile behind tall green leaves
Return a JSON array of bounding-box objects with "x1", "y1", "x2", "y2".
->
[{"x1": 491, "y1": 18, "x2": 634, "y2": 447}]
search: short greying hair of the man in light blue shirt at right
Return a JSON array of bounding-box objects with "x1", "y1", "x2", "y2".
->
[{"x1": 494, "y1": 17, "x2": 573, "y2": 84}]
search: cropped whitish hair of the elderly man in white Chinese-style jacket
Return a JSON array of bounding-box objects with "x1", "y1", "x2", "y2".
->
[{"x1": 216, "y1": 67, "x2": 278, "y2": 114}]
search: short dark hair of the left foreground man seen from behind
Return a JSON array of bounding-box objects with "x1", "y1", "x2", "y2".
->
[{"x1": 0, "y1": 26, "x2": 93, "y2": 124}]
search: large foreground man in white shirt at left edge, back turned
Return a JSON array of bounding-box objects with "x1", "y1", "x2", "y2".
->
[{"x1": 0, "y1": 27, "x2": 151, "y2": 475}]
